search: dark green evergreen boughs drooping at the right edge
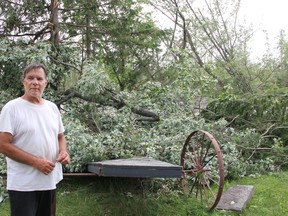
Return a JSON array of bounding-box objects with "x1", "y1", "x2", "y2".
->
[{"x1": 202, "y1": 94, "x2": 288, "y2": 145}]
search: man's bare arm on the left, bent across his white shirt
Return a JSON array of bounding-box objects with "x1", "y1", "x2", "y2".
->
[{"x1": 0, "y1": 132, "x2": 55, "y2": 175}]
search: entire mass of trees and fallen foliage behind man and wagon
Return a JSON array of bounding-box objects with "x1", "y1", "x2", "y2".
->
[{"x1": 0, "y1": 0, "x2": 288, "y2": 202}]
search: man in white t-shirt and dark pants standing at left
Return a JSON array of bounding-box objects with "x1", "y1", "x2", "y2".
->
[{"x1": 0, "y1": 63, "x2": 70, "y2": 216}]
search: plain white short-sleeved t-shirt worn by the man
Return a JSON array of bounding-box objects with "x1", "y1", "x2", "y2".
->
[{"x1": 0, "y1": 98, "x2": 64, "y2": 191}]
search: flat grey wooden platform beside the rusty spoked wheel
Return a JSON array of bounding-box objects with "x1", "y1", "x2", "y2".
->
[{"x1": 88, "y1": 157, "x2": 182, "y2": 178}]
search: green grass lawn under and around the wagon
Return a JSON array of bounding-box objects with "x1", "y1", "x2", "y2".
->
[{"x1": 0, "y1": 172, "x2": 288, "y2": 216}]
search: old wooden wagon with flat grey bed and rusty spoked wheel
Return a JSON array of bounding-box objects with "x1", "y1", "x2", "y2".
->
[{"x1": 68, "y1": 130, "x2": 224, "y2": 210}]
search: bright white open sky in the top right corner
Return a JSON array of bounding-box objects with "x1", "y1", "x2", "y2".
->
[{"x1": 240, "y1": 0, "x2": 288, "y2": 58}]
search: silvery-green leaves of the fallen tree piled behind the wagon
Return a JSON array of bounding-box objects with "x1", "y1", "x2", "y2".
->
[{"x1": 61, "y1": 69, "x2": 275, "y2": 178}]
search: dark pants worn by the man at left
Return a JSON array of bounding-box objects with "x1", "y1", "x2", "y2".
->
[{"x1": 8, "y1": 190, "x2": 56, "y2": 216}]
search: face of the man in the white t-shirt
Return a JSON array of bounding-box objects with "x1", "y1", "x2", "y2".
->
[{"x1": 22, "y1": 68, "x2": 48, "y2": 98}]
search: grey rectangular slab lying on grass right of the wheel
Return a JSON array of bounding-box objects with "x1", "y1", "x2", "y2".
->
[{"x1": 216, "y1": 185, "x2": 255, "y2": 211}]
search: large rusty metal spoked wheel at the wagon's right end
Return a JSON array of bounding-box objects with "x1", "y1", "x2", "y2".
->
[{"x1": 180, "y1": 130, "x2": 224, "y2": 210}]
